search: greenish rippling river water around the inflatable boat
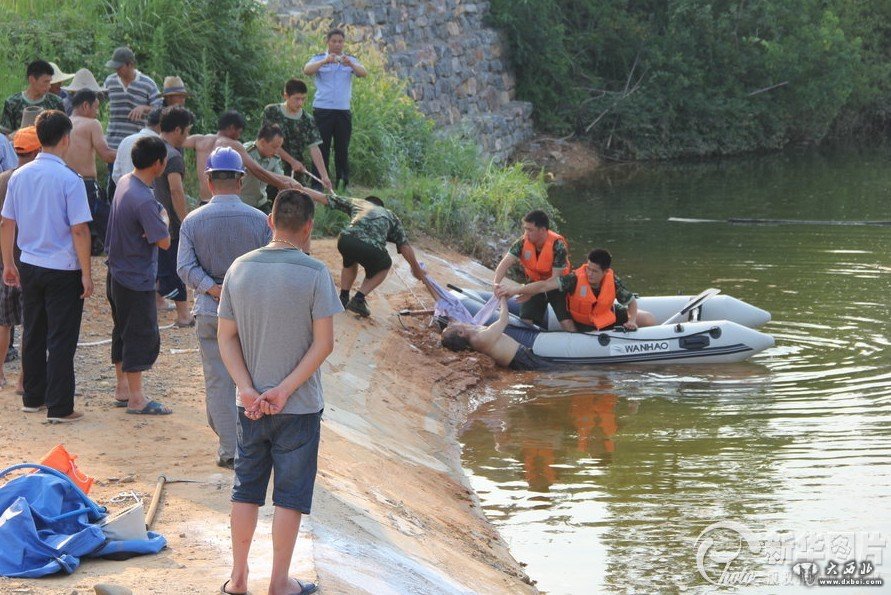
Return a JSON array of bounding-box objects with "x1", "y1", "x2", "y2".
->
[{"x1": 461, "y1": 149, "x2": 891, "y2": 593}]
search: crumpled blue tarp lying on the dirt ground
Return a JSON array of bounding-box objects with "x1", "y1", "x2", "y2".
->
[{"x1": 0, "y1": 465, "x2": 167, "y2": 578}]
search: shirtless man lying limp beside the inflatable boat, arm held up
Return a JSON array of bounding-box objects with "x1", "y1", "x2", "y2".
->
[{"x1": 442, "y1": 297, "x2": 558, "y2": 370}]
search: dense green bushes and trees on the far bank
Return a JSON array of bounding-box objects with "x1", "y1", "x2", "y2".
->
[{"x1": 492, "y1": 0, "x2": 891, "y2": 159}]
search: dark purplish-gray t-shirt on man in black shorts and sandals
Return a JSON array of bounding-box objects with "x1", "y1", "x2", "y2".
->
[{"x1": 105, "y1": 174, "x2": 169, "y2": 291}]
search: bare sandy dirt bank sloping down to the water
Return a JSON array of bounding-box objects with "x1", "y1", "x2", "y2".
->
[{"x1": 0, "y1": 240, "x2": 534, "y2": 593}]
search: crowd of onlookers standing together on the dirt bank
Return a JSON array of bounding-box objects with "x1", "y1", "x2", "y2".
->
[{"x1": 0, "y1": 29, "x2": 380, "y2": 593}]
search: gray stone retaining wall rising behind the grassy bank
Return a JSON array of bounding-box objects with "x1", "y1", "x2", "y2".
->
[{"x1": 269, "y1": 0, "x2": 532, "y2": 161}]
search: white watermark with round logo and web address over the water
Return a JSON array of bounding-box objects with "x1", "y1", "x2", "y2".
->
[{"x1": 694, "y1": 521, "x2": 887, "y2": 588}]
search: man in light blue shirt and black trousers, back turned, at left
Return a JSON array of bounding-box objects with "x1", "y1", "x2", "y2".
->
[{"x1": 0, "y1": 110, "x2": 93, "y2": 423}]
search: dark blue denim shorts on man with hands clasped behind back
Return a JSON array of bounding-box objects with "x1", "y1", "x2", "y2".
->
[{"x1": 232, "y1": 407, "x2": 322, "y2": 514}]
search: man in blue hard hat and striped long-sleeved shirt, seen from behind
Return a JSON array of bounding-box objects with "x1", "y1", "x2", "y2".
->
[{"x1": 176, "y1": 147, "x2": 272, "y2": 469}]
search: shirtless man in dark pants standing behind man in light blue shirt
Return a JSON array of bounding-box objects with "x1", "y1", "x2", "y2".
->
[{"x1": 65, "y1": 89, "x2": 116, "y2": 256}]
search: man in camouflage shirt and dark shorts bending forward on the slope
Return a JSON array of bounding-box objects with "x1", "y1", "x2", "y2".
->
[{"x1": 300, "y1": 188, "x2": 425, "y2": 316}]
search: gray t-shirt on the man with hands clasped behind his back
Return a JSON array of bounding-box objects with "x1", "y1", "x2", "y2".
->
[{"x1": 219, "y1": 248, "x2": 343, "y2": 414}]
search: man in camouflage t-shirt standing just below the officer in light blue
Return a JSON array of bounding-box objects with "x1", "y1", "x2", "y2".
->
[{"x1": 263, "y1": 79, "x2": 331, "y2": 190}]
